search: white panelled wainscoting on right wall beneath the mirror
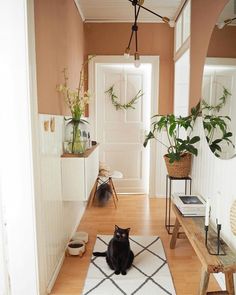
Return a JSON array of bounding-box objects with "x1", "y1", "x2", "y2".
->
[{"x1": 192, "y1": 118, "x2": 236, "y2": 285}]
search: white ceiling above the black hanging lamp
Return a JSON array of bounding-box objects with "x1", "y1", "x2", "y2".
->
[{"x1": 76, "y1": 0, "x2": 183, "y2": 22}]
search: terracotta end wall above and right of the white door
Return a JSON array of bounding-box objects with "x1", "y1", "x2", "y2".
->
[{"x1": 85, "y1": 23, "x2": 174, "y2": 114}]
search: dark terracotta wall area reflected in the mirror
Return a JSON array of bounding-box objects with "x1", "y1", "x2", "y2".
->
[{"x1": 207, "y1": 26, "x2": 236, "y2": 58}]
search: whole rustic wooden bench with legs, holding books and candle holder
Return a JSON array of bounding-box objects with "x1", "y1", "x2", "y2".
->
[{"x1": 170, "y1": 204, "x2": 236, "y2": 295}]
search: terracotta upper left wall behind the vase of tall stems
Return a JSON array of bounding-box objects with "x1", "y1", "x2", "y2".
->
[{"x1": 35, "y1": 0, "x2": 84, "y2": 115}]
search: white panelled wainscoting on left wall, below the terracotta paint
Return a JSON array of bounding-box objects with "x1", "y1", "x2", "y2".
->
[{"x1": 37, "y1": 114, "x2": 85, "y2": 295}]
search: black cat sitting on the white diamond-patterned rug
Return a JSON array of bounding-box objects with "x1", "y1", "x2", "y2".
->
[{"x1": 93, "y1": 225, "x2": 134, "y2": 275}]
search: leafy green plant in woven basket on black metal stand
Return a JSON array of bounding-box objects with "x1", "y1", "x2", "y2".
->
[{"x1": 143, "y1": 104, "x2": 200, "y2": 178}]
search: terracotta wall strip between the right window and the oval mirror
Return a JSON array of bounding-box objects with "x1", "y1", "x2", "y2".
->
[{"x1": 189, "y1": 0, "x2": 228, "y2": 108}]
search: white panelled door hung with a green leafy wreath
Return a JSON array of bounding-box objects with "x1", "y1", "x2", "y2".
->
[{"x1": 96, "y1": 64, "x2": 152, "y2": 193}]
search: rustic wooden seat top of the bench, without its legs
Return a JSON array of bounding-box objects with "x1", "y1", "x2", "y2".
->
[{"x1": 172, "y1": 204, "x2": 236, "y2": 273}]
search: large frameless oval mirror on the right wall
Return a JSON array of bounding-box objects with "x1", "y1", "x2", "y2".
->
[{"x1": 202, "y1": 0, "x2": 236, "y2": 159}]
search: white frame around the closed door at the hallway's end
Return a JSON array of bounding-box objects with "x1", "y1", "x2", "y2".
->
[{"x1": 89, "y1": 55, "x2": 159, "y2": 197}]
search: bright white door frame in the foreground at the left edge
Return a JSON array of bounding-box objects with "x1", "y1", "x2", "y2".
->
[{"x1": 0, "y1": 0, "x2": 40, "y2": 295}]
